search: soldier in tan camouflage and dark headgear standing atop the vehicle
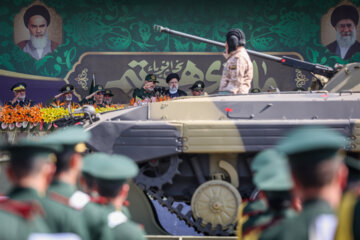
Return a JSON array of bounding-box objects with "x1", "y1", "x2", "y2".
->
[{"x1": 219, "y1": 28, "x2": 253, "y2": 95}]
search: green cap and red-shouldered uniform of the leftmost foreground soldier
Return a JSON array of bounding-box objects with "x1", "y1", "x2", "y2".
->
[{"x1": 0, "y1": 140, "x2": 60, "y2": 239}]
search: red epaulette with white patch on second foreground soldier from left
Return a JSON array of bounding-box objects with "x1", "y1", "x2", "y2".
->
[{"x1": 49, "y1": 191, "x2": 90, "y2": 210}]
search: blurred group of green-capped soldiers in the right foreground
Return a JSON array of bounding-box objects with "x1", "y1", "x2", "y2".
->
[{"x1": 237, "y1": 127, "x2": 360, "y2": 240}]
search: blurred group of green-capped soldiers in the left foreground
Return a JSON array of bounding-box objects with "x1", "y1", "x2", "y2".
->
[{"x1": 0, "y1": 127, "x2": 145, "y2": 240}]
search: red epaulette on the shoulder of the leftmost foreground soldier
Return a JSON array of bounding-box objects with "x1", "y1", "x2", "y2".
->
[{"x1": 0, "y1": 198, "x2": 44, "y2": 220}]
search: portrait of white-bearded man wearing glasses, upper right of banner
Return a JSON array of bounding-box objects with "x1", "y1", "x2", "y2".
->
[{"x1": 326, "y1": 5, "x2": 360, "y2": 60}]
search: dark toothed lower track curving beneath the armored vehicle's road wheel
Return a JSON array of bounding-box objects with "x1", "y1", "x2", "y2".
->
[{"x1": 139, "y1": 186, "x2": 236, "y2": 236}]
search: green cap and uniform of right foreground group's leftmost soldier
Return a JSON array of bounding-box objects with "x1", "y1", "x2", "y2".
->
[{"x1": 242, "y1": 149, "x2": 295, "y2": 239}]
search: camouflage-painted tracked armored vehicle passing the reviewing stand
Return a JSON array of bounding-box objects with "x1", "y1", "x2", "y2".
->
[{"x1": 80, "y1": 27, "x2": 360, "y2": 235}]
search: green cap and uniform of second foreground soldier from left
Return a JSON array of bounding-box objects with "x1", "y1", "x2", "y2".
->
[{"x1": 41, "y1": 126, "x2": 109, "y2": 239}]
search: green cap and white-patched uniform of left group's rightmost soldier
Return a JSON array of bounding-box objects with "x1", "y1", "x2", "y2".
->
[{"x1": 84, "y1": 153, "x2": 145, "y2": 240}]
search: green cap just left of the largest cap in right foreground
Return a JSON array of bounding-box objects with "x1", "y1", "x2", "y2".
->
[{"x1": 254, "y1": 150, "x2": 293, "y2": 191}]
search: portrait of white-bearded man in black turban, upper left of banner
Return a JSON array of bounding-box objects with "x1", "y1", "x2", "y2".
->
[{"x1": 17, "y1": 5, "x2": 59, "y2": 60}]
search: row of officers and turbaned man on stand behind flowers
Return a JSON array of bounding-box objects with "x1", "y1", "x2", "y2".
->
[{"x1": 6, "y1": 73, "x2": 205, "y2": 108}]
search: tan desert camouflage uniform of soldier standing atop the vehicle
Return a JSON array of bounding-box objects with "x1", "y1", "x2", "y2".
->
[{"x1": 219, "y1": 47, "x2": 253, "y2": 94}]
